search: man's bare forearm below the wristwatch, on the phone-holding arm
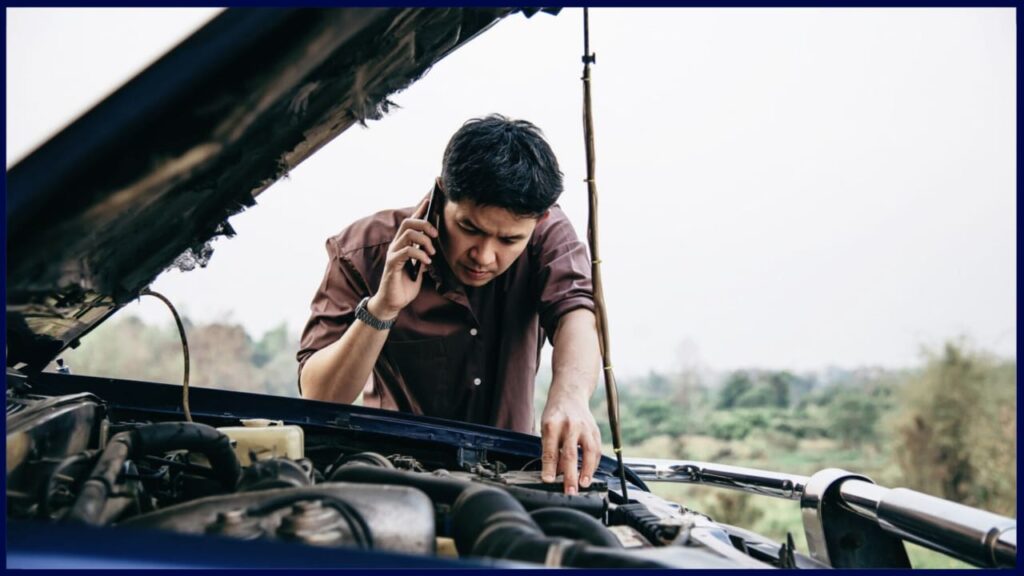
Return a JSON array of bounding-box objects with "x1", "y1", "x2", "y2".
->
[{"x1": 299, "y1": 297, "x2": 389, "y2": 404}]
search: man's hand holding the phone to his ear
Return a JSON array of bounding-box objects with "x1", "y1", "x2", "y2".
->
[{"x1": 367, "y1": 200, "x2": 437, "y2": 320}]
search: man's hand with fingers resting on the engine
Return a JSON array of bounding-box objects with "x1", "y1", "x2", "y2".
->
[{"x1": 541, "y1": 379, "x2": 601, "y2": 494}]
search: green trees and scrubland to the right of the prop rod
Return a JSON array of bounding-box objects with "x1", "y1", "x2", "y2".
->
[{"x1": 591, "y1": 340, "x2": 1017, "y2": 517}]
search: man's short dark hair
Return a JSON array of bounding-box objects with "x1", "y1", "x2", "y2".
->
[{"x1": 441, "y1": 114, "x2": 562, "y2": 217}]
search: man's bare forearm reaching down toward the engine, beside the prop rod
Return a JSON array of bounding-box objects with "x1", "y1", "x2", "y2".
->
[{"x1": 548, "y1": 308, "x2": 601, "y2": 402}]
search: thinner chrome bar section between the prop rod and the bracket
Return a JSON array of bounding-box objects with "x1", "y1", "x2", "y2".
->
[{"x1": 624, "y1": 458, "x2": 808, "y2": 500}]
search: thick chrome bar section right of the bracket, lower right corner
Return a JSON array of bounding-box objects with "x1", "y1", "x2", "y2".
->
[{"x1": 839, "y1": 480, "x2": 1017, "y2": 567}]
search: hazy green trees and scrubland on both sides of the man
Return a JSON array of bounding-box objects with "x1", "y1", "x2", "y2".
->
[{"x1": 62, "y1": 316, "x2": 1017, "y2": 516}]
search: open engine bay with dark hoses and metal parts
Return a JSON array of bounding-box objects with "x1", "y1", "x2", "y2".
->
[{"x1": 7, "y1": 372, "x2": 822, "y2": 568}]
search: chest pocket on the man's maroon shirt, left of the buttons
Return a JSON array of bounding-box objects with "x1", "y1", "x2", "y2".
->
[{"x1": 385, "y1": 337, "x2": 459, "y2": 418}]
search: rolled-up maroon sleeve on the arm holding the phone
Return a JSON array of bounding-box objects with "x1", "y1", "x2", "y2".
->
[{"x1": 295, "y1": 238, "x2": 370, "y2": 393}]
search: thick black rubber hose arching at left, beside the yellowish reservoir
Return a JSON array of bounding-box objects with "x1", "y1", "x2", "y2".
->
[{"x1": 67, "y1": 422, "x2": 242, "y2": 526}]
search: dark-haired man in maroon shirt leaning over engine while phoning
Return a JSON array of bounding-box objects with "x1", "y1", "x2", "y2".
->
[{"x1": 297, "y1": 115, "x2": 601, "y2": 494}]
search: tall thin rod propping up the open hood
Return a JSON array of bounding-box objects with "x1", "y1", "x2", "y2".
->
[{"x1": 582, "y1": 7, "x2": 630, "y2": 502}]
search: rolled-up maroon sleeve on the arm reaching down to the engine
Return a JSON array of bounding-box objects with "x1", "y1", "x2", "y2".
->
[{"x1": 534, "y1": 206, "x2": 594, "y2": 340}]
